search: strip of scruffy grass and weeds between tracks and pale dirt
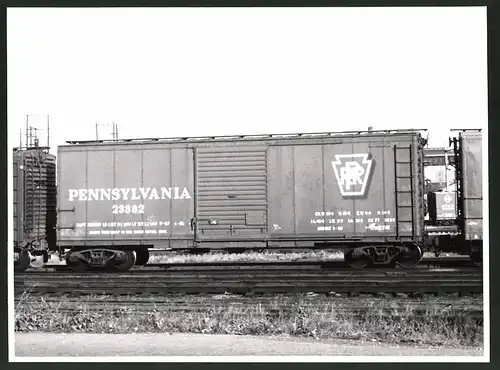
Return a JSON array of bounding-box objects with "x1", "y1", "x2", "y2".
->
[{"x1": 15, "y1": 295, "x2": 483, "y2": 347}]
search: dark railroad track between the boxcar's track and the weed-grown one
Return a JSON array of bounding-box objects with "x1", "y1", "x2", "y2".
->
[{"x1": 14, "y1": 266, "x2": 483, "y2": 294}]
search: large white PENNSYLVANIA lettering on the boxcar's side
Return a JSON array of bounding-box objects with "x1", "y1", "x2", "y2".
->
[{"x1": 68, "y1": 186, "x2": 191, "y2": 202}]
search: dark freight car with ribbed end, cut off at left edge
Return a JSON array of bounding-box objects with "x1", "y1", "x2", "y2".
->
[{"x1": 13, "y1": 148, "x2": 56, "y2": 271}]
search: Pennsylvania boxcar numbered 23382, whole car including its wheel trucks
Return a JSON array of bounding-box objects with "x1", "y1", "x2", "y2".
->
[{"x1": 58, "y1": 131, "x2": 424, "y2": 269}]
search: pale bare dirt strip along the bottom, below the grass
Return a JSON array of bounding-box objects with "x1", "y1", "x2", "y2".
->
[{"x1": 15, "y1": 333, "x2": 484, "y2": 357}]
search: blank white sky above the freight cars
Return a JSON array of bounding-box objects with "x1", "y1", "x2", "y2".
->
[{"x1": 7, "y1": 7, "x2": 488, "y2": 153}]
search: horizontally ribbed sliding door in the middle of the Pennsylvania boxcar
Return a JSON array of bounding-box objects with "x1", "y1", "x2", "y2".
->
[{"x1": 195, "y1": 143, "x2": 267, "y2": 241}]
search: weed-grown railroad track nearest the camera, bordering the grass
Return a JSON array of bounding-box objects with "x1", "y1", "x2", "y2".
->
[{"x1": 15, "y1": 293, "x2": 483, "y2": 318}]
